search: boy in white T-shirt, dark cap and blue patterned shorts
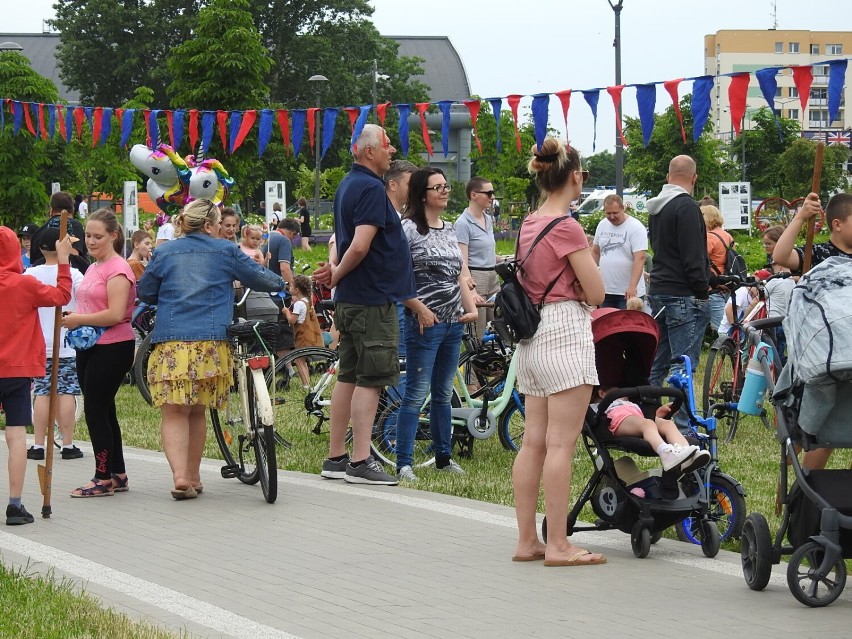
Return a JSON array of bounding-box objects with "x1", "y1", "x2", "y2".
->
[{"x1": 24, "y1": 228, "x2": 83, "y2": 460}]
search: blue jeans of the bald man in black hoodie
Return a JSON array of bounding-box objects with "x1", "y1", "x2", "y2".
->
[{"x1": 648, "y1": 295, "x2": 710, "y2": 386}]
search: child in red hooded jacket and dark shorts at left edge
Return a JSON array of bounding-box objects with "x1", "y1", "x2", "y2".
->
[{"x1": 0, "y1": 226, "x2": 71, "y2": 526}]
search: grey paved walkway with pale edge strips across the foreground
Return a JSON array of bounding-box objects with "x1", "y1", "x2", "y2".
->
[{"x1": 0, "y1": 443, "x2": 852, "y2": 639}]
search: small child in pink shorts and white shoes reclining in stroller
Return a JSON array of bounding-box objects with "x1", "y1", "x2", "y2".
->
[{"x1": 597, "y1": 387, "x2": 710, "y2": 475}]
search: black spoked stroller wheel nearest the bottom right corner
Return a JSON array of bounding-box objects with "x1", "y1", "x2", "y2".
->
[{"x1": 787, "y1": 541, "x2": 846, "y2": 608}]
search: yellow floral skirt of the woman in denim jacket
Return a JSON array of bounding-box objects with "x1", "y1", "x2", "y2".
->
[{"x1": 148, "y1": 340, "x2": 234, "y2": 410}]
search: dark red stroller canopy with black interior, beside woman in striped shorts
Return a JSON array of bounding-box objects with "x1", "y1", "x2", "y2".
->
[{"x1": 592, "y1": 308, "x2": 660, "y2": 387}]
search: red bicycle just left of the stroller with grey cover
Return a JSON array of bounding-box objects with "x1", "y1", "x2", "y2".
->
[{"x1": 702, "y1": 273, "x2": 790, "y2": 443}]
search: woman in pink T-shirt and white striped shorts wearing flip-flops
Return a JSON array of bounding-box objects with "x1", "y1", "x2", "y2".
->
[{"x1": 512, "y1": 138, "x2": 606, "y2": 566}]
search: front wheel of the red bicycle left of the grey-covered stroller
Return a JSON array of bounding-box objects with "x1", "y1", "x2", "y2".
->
[{"x1": 702, "y1": 338, "x2": 742, "y2": 442}]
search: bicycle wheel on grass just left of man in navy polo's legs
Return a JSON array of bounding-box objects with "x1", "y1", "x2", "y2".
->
[{"x1": 266, "y1": 347, "x2": 338, "y2": 435}]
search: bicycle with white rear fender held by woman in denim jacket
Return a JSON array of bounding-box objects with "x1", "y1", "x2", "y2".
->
[{"x1": 210, "y1": 289, "x2": 278, "y2": 504}]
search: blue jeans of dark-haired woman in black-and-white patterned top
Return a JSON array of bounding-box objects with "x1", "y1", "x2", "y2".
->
[{"x1": 396, "y1": 315, "x2": 464, "y2": 470}]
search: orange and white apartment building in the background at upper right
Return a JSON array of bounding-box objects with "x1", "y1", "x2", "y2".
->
[{"x1": 704, "y1": 29, "x2": 852, "y2": 138}]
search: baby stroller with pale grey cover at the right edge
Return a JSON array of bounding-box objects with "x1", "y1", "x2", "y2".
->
[{"x1": 741, "y1": 257, "x2": 852, "y2": 607}]
